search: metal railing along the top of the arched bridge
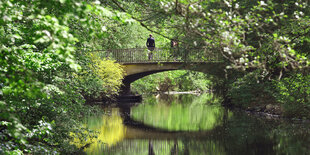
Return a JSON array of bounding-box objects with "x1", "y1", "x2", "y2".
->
[{"x1": 93, "y1": 48, "x2": 223, "y2": 63}]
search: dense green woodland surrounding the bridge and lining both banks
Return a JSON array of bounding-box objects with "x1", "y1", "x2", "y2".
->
[{"x1": 0, "y1": 0, "x2": 310, "y2": 154}]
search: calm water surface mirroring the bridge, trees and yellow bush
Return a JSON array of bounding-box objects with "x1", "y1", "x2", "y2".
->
[{"x1": 76, "y1": 94, "x2": 310, "y2": 155}]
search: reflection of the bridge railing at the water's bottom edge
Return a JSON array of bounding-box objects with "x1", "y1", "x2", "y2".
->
[{"x1": 97, "y1": 139, "x2": 226, "y2": 155}]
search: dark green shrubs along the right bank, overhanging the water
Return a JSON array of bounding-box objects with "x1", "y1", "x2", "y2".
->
[{"x1": 227, "y1": 72, "x2": 310, "y2": 119}]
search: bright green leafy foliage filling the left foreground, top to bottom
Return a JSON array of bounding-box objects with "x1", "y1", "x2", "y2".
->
[{"x1": 0, "y1": 0, "x2": 125, "y2": 154}]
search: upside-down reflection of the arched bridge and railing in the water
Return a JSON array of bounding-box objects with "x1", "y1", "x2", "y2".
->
[{"x1": 95, "y1": 107, "x2": 228, "y2": 155}]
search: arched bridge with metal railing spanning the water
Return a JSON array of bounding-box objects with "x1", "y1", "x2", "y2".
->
[{"x1": 94, "y1": 48, "x2": 225, "y2": 95}]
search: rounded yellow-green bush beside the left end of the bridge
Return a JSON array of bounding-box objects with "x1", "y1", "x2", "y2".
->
[{"x1": 73, "y1": 51, "x2": 124, "y2": 102}]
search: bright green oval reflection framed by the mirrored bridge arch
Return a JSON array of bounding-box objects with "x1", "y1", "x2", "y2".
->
[{"x1": 131, "y1": 100, "x2": 231, "y2": 131}]
